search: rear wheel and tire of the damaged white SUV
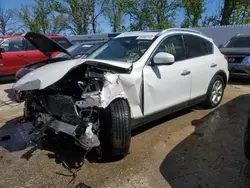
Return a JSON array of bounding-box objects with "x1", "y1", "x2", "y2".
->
[{"x1": 204, "y1": 75, "x2": 225, "y2": 109}]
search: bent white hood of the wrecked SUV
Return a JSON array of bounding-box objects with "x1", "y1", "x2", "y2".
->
[{"x1": 13, "y1": 59, "x2": 133, "y2": 91}]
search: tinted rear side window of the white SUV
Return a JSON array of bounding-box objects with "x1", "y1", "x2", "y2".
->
[{"x1": 184, "y1": 35, "x2": 213, "y2": 58}]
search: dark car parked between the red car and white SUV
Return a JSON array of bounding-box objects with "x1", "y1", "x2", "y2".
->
[{"x1": 15, "y1": 39, "x2": 106, "y2": 102}]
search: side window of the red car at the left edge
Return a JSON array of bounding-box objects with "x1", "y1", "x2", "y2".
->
[{"x1": 1, "y1": 38, "x2": 24, "y2": 52}]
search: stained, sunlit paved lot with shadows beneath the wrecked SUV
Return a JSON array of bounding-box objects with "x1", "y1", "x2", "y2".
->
[{"x1": 0, "y1": 83, "x2": 250, "y2": 188}]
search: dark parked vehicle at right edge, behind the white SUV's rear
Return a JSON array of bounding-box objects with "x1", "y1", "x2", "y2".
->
[{"x1": 220, "y1": 35, "x2": 250, "y2": 78}]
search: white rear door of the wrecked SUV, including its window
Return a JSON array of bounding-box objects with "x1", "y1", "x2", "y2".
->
[{"x1": 183, "y1": 34, "x2": 219, "y2": 99}]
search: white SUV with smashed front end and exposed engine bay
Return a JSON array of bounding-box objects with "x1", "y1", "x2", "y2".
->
[{"x1": 13, "y1": 28, "x2": 228, "y2": 157}]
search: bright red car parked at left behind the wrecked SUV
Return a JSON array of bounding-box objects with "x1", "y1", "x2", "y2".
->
[{"x1": 0, "y1": 35, "x2": 72, "y2": 76}]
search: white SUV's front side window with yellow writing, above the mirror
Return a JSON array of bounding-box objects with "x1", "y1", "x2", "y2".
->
[{"x1": 156, "y1": 35, "x2": 186, "y2": 61}]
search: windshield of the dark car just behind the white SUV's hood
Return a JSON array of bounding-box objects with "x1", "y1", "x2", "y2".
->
[{"x1": 56, "y1": 43, "x2": 103, "y2": 58}]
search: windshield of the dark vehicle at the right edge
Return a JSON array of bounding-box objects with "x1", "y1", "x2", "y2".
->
[{"x1": 225, "y1": 37, "x2": 250, "y2": 48}]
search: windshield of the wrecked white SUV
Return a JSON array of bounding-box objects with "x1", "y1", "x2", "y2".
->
[{"x1": 88, "y1": 36, "x2": 153, "y2": 63}]
